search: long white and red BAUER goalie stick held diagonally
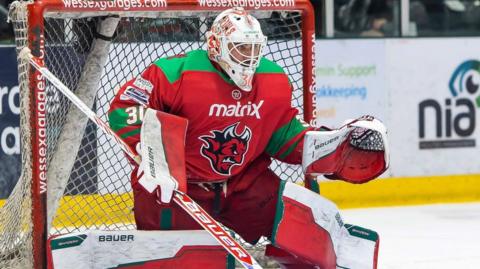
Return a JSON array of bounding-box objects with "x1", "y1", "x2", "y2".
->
[{"x1": 19, "y1": 47, "x2": 262, "y2": 269}]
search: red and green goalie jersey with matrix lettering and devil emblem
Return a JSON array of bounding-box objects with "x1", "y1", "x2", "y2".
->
[{"x1": 109, "y1": 50, "x2": 306, "y2": 182}]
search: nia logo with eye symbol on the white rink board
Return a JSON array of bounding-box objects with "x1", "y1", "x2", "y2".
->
[{"x1": 418, "y1": 60, "x2": 480, "y2": 149}]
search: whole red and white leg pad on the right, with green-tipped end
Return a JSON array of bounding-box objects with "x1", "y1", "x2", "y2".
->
[{"x1": 267, "y1": 182, "x2": 378, "y2": 269}]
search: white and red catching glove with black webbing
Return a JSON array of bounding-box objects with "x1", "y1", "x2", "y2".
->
[{"x1": 302, "y1": 116, "x2": 389, "y2": 183}]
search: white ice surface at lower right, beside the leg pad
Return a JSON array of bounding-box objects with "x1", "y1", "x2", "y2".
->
[{"x1": 342, "y1": 203, "x2": 480, "y2": 269}]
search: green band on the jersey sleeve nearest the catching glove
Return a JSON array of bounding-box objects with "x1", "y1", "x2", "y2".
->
[{"x1": 265, "y1": 118, "x2": 305, "y2": 158}]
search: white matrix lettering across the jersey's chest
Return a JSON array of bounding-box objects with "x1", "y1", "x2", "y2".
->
[{"x1": 208, "y1": 100, "x2": 264, "y2": 119}]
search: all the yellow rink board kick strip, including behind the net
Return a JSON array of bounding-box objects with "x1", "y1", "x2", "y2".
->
[{"x1": 0, "y1": 175, "x2": 480, "y2": 226}]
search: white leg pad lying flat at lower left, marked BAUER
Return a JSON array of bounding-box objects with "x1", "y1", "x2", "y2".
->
[{"x1": 48, "y1": 230, "x2": 227, "y2": 269}]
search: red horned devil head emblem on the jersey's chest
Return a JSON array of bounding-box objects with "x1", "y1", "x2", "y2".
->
[{"x1": 199, "y1": 122, "x2": 252, "y2": 176}]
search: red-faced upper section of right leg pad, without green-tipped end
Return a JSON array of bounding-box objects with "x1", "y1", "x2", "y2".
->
[{"x1": 272, "y1": 182, "x2": 343, "y2": 269}]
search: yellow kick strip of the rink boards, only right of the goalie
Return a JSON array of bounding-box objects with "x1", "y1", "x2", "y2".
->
[{"x1": 320, "y1": 174, "x2": 480, "y2": 208}]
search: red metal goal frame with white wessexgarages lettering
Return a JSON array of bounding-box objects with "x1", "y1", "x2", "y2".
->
[{"x1": 27, "y1": 0, "x2": 316, "y2": 269}]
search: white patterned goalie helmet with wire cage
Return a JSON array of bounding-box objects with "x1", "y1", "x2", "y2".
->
[{"x1": 206, "y1": 7, "x2": 267, "y2": 92}]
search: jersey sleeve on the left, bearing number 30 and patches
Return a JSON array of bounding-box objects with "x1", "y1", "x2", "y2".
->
[{"x1": 108, "y1": 60, "x2": 175, "y2": 153}]
